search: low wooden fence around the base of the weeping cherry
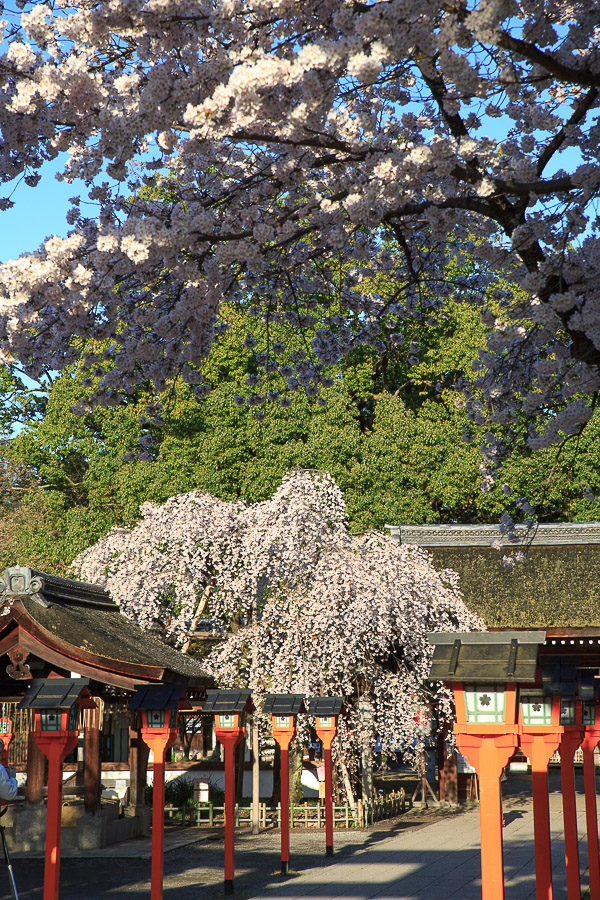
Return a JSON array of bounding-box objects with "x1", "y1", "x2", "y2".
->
[{"x1": 165, "y1": 789, "x2": 408, "y2": 828}]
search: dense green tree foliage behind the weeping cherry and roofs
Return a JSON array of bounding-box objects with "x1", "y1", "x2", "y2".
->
[{"x1": 1, "y1": 284, "x2": 600, "y2": 571}]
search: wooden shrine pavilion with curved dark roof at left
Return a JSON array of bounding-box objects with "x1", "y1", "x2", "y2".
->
[{"x1": 0, "y1": 566, "x2": 213, "y2": 850}]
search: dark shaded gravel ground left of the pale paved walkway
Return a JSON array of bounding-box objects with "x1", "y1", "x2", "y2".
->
[{"x1": 0, "y1": 809, "x2": 464, "y2": 900}]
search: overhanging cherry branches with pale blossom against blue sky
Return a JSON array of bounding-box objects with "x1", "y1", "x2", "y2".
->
[{"x1": 0, "y1": 0, "x2": 600, "y2": 476}]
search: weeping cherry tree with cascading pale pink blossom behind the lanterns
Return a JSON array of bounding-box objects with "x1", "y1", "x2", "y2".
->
[{"x1": 74, "y1": 471, "x2": 483, "y2": 800}]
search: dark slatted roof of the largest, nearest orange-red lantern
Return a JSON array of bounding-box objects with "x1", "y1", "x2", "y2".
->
[{"x1": 429, "y1": 631, "x2": 546, "y2": 684}]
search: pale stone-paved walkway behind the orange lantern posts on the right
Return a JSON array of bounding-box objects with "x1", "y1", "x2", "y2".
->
[{"x1": 251, "y1": 793, "x2": 587, "y2": 900}]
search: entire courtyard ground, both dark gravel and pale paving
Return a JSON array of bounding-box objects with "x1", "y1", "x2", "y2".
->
[{"x1": 0, "y1": 770, "x2": 587, "y2": 900}]
